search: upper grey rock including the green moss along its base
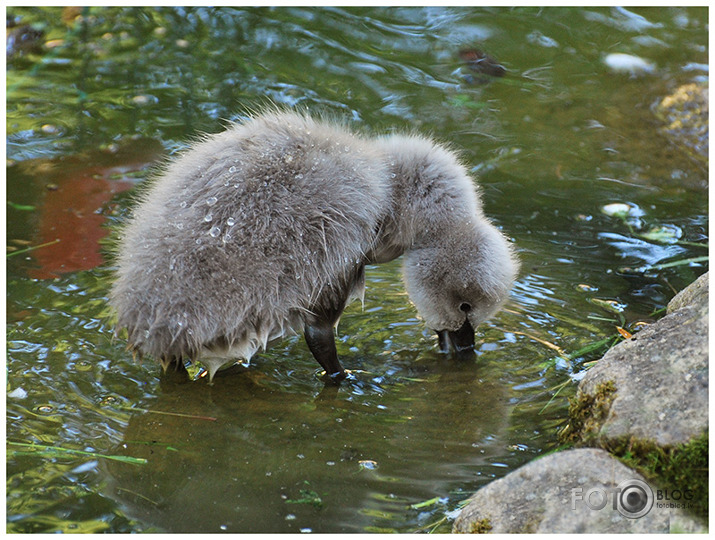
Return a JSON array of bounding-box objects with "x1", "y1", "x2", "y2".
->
[{"x1": 559, "y1": 273, "x2": 709, "y2": 518}]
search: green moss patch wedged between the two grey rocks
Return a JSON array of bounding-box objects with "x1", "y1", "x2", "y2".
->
[{"x1": 605, "y1": 431, "x2": 709, "y2": 520}]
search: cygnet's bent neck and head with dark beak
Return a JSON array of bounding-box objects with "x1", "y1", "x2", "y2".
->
[{"x1": 375, "y1": 135, "x2": 519, "y2": 353}]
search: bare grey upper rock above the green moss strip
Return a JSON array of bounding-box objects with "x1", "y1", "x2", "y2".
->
[{"x1": 570, "y1": 274, "x2": 709, "y2": 447}]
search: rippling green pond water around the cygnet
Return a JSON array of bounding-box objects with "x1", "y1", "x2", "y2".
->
[{"x1": 7, "y1": 7, "x2": 708, "y2": 532}]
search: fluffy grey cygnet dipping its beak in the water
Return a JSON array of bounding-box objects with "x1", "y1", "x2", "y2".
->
[{"x1": 110, "y1": 110, "x2": 518, "y2": 383}]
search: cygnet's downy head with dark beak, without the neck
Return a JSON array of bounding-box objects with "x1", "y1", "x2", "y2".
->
[{"x1": 404, "y1": 218, "x2": 518, "y2": 353}]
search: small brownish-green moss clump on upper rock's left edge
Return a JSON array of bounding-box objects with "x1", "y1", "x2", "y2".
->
[{"x1": 559, "y1": 381, "x2": 616, "y2": 444}]
